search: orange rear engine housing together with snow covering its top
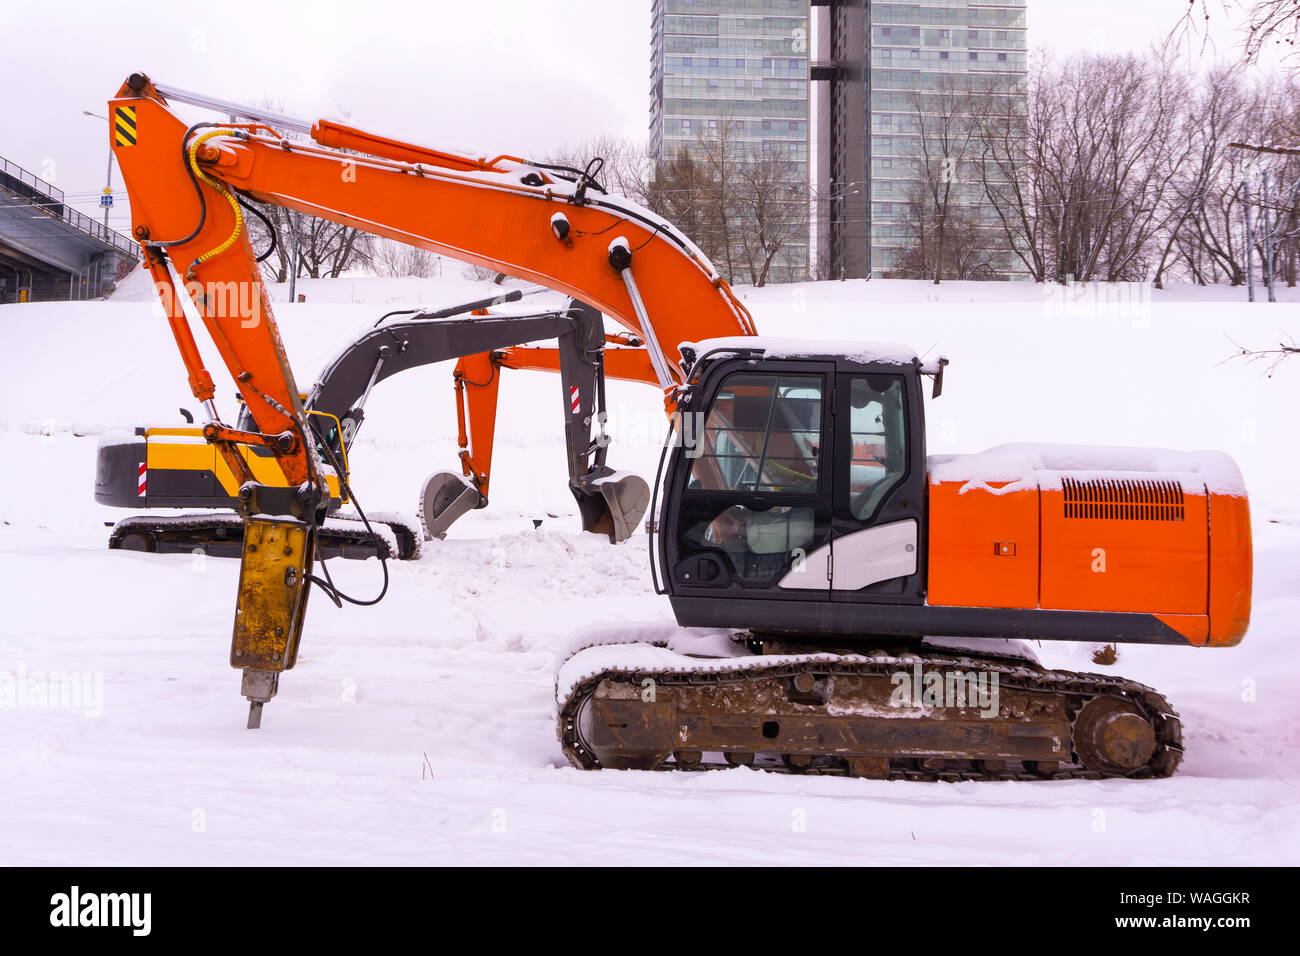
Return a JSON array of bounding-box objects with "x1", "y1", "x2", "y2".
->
[{"x1": 927, "y1": 445, "x2": 1252, "y2": 646}]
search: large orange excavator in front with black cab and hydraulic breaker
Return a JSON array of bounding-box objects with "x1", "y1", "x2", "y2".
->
[{"x1": 109, "y1": 74, "x2": 1251, "y2": 779}]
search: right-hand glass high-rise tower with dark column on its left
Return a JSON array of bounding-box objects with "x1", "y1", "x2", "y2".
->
[{"x1": 811, "y1": 0, "x2": 1027, "y2": 277}]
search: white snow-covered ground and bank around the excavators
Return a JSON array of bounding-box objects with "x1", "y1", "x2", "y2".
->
[{"x1": 0, "y1": 270, "x2": 1300, "y2": 865}]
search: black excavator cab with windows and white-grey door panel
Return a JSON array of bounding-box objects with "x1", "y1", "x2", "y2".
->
[{"x1": 658, "y1": 346, "x2": 926, "y2": 633}]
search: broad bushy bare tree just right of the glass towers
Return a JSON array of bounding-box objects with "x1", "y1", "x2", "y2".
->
[{"x1": 980, "y1": 52, "x2": 1192, "y2": 282}]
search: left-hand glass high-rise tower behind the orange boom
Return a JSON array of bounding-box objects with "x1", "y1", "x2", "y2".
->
[{"x1": 650, "y1": 0, "x2": 809, "y2": 282}]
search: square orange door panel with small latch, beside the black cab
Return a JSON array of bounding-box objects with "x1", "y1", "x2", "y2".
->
[{"x1": 928, "y1": 481, "x2": 1039, "y2": 607}]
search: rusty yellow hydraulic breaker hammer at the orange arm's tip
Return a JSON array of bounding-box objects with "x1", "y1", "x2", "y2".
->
[{"x1": 230, "y1": 516, "x2": 316, "y2": 730}]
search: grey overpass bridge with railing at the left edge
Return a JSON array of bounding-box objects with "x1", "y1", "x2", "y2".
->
[{"x1": 0, "y1": 157, "x2": 140, "y2": 304}]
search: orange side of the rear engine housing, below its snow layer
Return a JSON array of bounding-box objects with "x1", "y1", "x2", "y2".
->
[{"x1": 927, "y1": 481, "x2": 1252, "y2": 646}]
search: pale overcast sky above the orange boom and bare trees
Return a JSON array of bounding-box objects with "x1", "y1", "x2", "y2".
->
[{"x1": 0, "y1": 0, "x2": 1263, "y2": 223}]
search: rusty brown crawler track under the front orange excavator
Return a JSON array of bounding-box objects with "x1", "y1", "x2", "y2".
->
[{"x1": 558, "y1": 645, "x2": 1183, "y2": 782}]
